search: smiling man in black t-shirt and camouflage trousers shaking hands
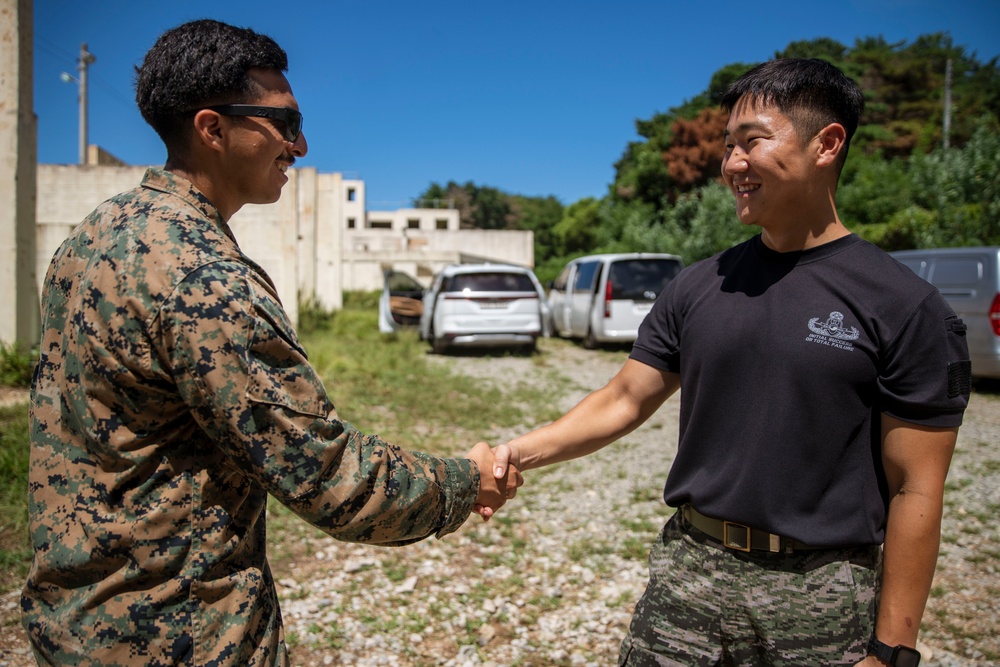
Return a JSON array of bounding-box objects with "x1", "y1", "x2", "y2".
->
[{"x1": 484, "y1": 59, "x2": 970, "y2": 666}]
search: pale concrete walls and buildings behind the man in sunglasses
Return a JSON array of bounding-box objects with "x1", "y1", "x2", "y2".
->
[{"x1": 35, "y1": 165, "x2": 534, "y2": 321}]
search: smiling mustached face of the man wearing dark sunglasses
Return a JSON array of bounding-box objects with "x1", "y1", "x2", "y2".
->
[{"x1": 225, "y1": 70, "x2": 309, "y2": 209}]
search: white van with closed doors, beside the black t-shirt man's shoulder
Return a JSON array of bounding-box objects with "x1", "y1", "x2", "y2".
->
[{"x1": 549, "y1": 253, "x2": 684, "y2": 349}]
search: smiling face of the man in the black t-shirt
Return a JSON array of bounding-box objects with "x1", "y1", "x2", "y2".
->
[{"x1": 722, "y1": 98, "x2": 825, "y2": 230}]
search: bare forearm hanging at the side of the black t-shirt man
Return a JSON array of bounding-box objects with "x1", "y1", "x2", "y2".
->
[{"x1": 875, "y1": 492, "x2": 942, "y2": 647}]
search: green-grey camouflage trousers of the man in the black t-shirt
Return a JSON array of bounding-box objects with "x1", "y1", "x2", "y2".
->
[{"x1": 618, "y1": 512, "x2": 882, "y2": 667}]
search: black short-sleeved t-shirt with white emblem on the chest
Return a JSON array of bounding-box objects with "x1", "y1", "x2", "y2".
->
[{"x1": 631, "y1": 235, "x2": 969, "y2": 546}]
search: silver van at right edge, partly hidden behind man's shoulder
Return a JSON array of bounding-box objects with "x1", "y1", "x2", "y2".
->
[{"x1": 889, "y1": 246, "x2": 1000, "y2": 379}]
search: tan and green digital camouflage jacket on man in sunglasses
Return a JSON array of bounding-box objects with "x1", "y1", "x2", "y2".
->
[{"x1": 21, "y1": 169, "x2": 479, "y2": 667}]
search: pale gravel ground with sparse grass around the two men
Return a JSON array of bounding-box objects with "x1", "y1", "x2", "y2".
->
[{"x1": 0, "y1": 341, "x2": 1000, "y2": 667}]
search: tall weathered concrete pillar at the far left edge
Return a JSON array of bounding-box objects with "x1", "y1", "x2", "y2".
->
[{"x1": 0, "y1": 0, "x2": 39, "y2": 347}]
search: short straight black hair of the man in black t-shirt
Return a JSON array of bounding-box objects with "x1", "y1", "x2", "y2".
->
[{"x1": 722, "y1": 58, "x2": 865, "y2": 166}]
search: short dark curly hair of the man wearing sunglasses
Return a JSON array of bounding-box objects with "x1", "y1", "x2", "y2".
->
[{"x1": 135, "y1": 19, "x2": 288, "y2": 153}]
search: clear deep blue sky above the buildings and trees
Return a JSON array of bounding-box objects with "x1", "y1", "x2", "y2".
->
[{"x1": 34, "y1": 0, "x2": 1000, "y2": 208}]
